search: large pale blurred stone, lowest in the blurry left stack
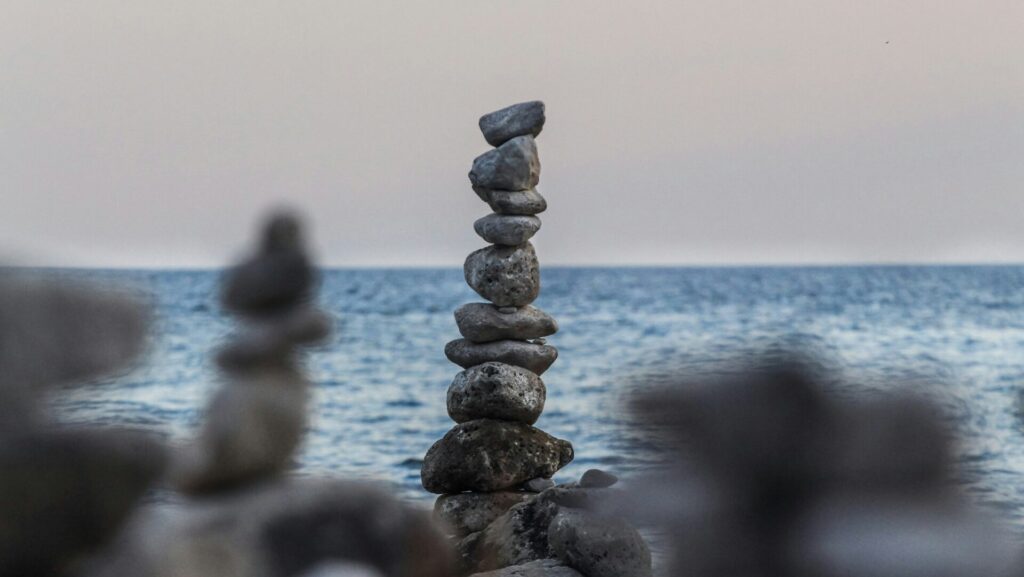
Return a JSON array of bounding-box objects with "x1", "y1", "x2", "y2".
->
[{"x1": 172, "y1": 367, "x2": 309, "y2": 494}]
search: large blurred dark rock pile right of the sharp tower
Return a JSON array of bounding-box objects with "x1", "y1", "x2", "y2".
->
[{"x1": 618, "y1": 352, "x2": 1022, "y2": 577}]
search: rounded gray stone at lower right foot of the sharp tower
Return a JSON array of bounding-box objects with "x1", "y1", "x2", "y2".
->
[{"x1": 548, "y1": 508, "x2": 652, "y2": 577}]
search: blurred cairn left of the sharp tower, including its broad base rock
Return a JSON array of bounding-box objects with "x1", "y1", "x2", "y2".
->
[{"x1": 88, "y1": 212, "x2": 452, "y2": 577}]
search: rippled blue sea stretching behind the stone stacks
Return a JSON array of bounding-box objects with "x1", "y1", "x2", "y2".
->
[{"x1": 48, "y1": 266, "x2": 1024, "y2": 529}]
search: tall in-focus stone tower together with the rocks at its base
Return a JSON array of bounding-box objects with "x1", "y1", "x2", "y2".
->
[{"x1": 422, "y1": 100, "x2": 651, "y2": 577}]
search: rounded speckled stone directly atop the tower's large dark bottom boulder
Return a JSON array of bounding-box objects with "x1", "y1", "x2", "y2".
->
[{"x1": 447, "y1": 363, "x2": 547, "y2": 424}]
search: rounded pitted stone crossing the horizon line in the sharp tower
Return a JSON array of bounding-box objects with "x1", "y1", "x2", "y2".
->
[{"x1": 463, "y1": 242, "x2": 541, "y2": 306}]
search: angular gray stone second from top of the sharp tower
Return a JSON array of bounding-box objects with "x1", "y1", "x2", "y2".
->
[{"x1": 469, "y1": 136, "x2": 541, "y2": 191}]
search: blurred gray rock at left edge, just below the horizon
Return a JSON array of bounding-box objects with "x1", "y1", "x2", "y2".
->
[{"x1": 0, "y1": 273, "x2": 150, "y2": 395}]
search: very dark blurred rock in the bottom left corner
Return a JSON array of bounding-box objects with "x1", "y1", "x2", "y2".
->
[{"x1": 0, "y1": 427, "x2": 165, "y2": 577}]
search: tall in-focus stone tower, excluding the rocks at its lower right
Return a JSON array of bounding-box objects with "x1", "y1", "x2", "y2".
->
[{"x1": 422, "y1": 101, "x2": 572, "y2": 518}]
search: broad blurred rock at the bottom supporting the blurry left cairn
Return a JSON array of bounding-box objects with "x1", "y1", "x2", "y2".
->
[{"x1": 88, "y1": 480, "x2": 454, "y2": 577}]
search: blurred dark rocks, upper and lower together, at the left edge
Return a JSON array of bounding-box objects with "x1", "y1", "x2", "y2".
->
[{"x1": 0, "y1": 270, "x2": 166, "y2": 577}]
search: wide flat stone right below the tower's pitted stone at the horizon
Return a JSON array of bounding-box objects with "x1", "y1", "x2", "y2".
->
[{"x1": 455, "y1": 302, "x2": 558, "y2": 343}]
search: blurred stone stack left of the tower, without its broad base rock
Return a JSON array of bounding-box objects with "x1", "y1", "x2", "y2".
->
[{"x1": 174, "y1": 213, "x2": 330, "y2": 494}]
